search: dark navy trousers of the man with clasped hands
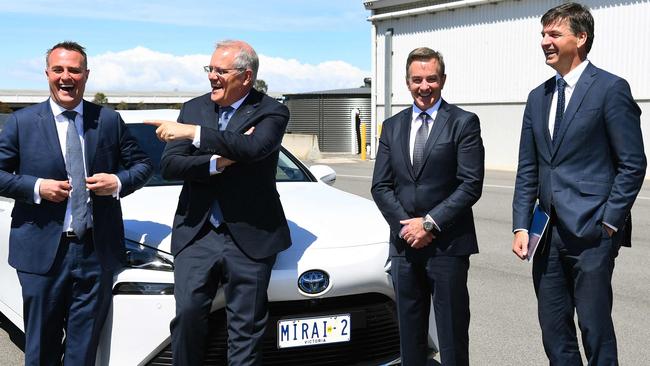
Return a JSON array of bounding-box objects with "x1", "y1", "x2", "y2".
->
[{"x1": 391, "y1": 256, "x2": 470, "y2": 366}]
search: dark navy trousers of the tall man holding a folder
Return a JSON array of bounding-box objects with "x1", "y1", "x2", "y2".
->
[{"x1": 533, "y1": 222, "x2": 618, "y2": 366}]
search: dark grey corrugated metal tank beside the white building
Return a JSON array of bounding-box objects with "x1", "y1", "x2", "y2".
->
[{"x1": 285, "y1": 95, "x2": 371, "y2": 153}]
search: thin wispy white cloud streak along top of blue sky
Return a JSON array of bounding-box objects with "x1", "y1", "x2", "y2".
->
[{"x1": 0, "y1": 0, "x2": 368, "y2": 31}]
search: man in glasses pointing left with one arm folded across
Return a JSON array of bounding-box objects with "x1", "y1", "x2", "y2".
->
[{"x1": 152, "y1": 41, "x2": 291, "y2": 366}]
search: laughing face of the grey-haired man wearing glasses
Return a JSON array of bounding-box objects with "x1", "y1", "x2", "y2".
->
[{"x1": 208, "y1": 47, "x2": 253, "y2": 107}]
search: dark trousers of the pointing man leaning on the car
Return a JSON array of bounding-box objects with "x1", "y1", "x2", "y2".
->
[{"x1": 170, "y1": 223, "x2": 275, "y2": 366}]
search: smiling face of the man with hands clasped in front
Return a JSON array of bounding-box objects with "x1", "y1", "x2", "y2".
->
[{"x1": 406, "y1": 58, "x2": 447, "y2": 111}]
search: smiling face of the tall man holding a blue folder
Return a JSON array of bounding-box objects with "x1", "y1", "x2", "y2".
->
[{"x1": 541, "y1": 19, "x2": 587, "y2": 76}]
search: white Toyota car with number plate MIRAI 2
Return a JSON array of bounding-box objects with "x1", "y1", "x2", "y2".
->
[{"x1": 0, "y1": 110, "x2": 435, "y2": 366}]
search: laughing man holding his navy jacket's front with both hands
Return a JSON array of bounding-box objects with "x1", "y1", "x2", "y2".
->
[{"x1": 0, "y1": 42, "x2": 152, "y2": 365}]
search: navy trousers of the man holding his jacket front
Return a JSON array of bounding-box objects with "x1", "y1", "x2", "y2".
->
[{"x1": 18, "y1": 235, "x2": 113, "y2": 366}]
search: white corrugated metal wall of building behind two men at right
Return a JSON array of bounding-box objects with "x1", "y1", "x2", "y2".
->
[{"x1": 374, "y1": 0, "x2": 650, "y2": 107}]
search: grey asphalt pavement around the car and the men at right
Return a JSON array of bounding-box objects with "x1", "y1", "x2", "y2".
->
[{"x1": 0, "y1": 155, "x2": 650, "y2": 366}]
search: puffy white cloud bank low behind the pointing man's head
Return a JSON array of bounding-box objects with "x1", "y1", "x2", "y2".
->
[{"x1": 82, "y1": 47, "x2": 370, "y2": 93}]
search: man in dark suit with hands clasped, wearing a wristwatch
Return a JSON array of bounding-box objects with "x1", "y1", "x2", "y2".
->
[{"x1": 372, "y1": 47, "x2": 484, "y2": 366}]
